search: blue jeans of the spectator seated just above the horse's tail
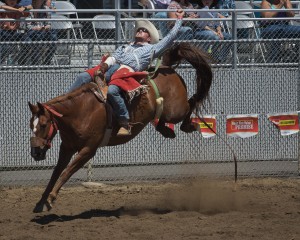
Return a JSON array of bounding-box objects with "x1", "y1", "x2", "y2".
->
[{"x1": 195, "y1": 29, "x2": 231, "y2": 62}]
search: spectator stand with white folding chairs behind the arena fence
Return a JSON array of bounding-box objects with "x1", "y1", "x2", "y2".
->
[{"x1": 0, "y1": 0, "x2": 300, "y2": 69}]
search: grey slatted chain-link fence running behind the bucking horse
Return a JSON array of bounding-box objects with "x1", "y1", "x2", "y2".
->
[{"x1": 0, "y1": 6, "x2": 300, "y2": 184}]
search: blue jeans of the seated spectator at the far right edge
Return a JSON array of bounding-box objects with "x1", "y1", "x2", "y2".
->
[{"x1": 261, "y1": 24, "x2": 300, "y2": 62}]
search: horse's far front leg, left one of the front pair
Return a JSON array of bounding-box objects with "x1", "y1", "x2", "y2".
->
[{"x1": 33, "y1": 144, "x2": 75, "y2": 213}]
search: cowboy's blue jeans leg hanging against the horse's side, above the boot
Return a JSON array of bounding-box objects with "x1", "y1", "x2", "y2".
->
[{"x1": 107, "y1": 85, "x2": 129, "y2": 125}]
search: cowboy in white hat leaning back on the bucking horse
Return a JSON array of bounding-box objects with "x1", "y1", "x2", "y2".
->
[{"x1": 70, "y1": 9, "x2": 184, "y2": 136}]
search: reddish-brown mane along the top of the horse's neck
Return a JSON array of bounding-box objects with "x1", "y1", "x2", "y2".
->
[{"x1": 47, "y1": 82, "x2": 96, "y2": 105}]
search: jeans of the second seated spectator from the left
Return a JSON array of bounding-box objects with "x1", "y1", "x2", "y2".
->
[{"x1": 27, "y1": 30, "x2": 58, "y2": 65}]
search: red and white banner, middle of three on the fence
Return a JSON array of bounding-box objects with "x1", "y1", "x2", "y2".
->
[{"x1": 226, "y1": 114, "x2": 258, "y2": 138}]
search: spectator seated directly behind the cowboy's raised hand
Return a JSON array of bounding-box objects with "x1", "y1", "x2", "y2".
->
[{"x1": 168, "y1": 0, "x2": 198, "y2": 40}]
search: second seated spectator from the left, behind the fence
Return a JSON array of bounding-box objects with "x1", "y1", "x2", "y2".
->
[{"x1": 27, "y1": 0, "x2": 58, "y2": 65}]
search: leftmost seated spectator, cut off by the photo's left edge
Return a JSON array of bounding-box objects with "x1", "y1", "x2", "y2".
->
[{"x1": 0, "y1": 0, "x2": 30, "y2": 65}]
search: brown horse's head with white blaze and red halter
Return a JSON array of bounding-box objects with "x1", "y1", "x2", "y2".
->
[{"x1": 28, "y1": 102, "x2": 57, "y2": 161}]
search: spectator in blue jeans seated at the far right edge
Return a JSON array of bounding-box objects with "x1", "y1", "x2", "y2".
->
[{"x1": 261, "y1": 0, "x2": 300, "y2": 62}]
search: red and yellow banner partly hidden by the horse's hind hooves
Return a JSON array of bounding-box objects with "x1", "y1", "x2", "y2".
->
[{"x1": 192, "y1": 115, "x2": 217, "y2": 138}]
